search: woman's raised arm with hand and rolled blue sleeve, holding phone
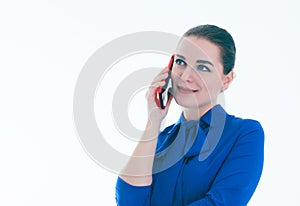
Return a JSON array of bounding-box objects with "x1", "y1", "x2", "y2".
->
[{"x1": 116, "y1": 68, "x2": 172, "y2": 206}]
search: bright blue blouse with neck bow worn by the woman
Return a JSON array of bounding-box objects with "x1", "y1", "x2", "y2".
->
[{"x1": 116, "y1": 105, "x2": 264, "y2": 206}]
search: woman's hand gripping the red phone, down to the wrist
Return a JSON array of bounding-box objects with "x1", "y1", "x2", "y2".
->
[{"x1": 146, "y1": 67, "x2": 173, "y2": 128}]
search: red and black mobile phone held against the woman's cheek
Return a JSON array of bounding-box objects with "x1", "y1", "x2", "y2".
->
[{"x1": 155, "y1": 54, "x2": 174, "y2": 109}]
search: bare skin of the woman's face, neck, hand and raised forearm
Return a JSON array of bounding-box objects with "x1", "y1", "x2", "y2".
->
[{"x1": 119, "y1": 36, "x2": 233, "y2": 186}]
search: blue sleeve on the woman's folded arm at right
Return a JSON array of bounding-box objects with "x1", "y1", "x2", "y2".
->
[{"x1": 188, "y1": 120, "x2": 264, "y2": 206}]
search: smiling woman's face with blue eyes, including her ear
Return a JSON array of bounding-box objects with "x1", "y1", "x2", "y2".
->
[{"x1": 172, "y1": 36, "x2": 233, "y2": 108}]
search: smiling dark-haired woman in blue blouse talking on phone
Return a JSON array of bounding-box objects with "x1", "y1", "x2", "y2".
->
[{"x1": 116, "y1": 25, "x2": 264, "y2": 206}]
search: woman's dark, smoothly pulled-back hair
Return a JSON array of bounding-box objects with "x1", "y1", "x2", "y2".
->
[{"x1": 183, "y1": 24, "x2": 236, "y2": 74}]
